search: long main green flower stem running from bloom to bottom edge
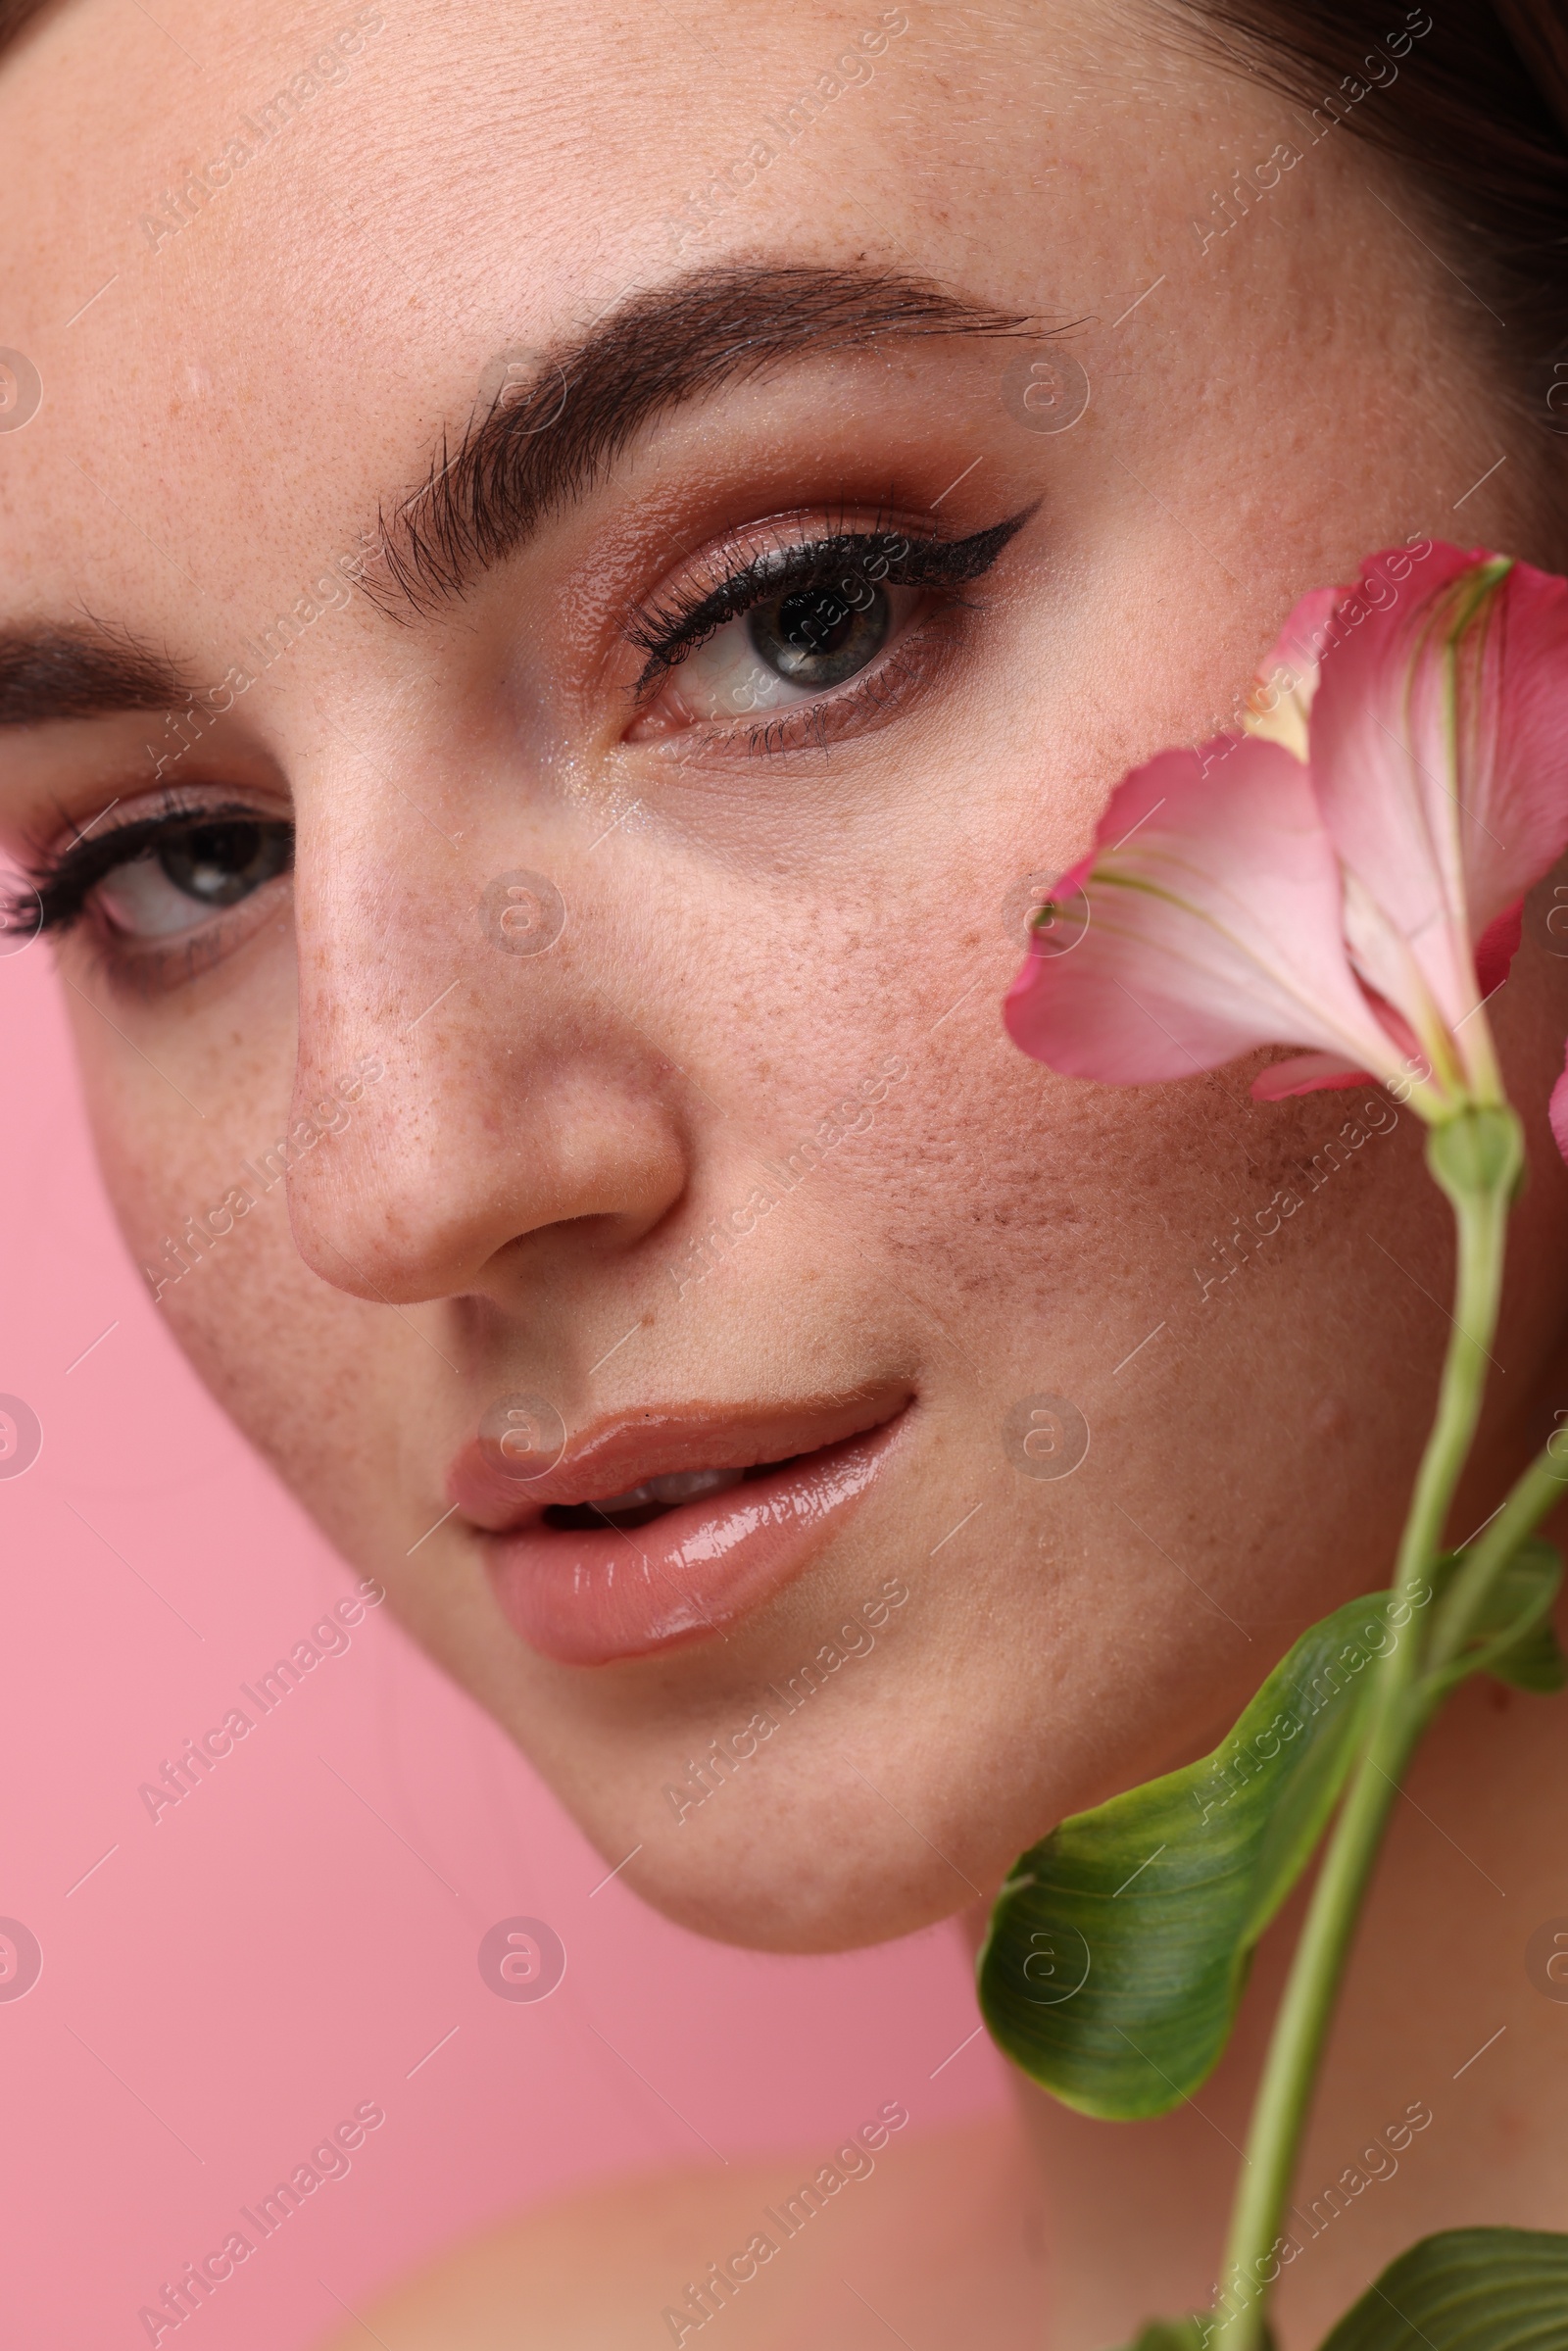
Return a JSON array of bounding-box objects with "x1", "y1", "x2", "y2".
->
[{"x1": 1215, "y1": 1112, "x2": 1519, "y2": 2351}]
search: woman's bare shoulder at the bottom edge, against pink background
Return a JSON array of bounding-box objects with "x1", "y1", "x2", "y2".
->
[{"x1": 310, "y1": 2118, "x2": 1044, "y2": 2351}]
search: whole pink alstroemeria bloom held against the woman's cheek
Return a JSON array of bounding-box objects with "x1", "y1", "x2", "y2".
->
[{"x1": 1004, "y1": 541, "x2": 1568, "y2": 1156}]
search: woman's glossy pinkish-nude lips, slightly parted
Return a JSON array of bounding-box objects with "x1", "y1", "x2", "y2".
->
[{"x1": 447, "y1": 1387, "x2": 909, "y2": 1664}]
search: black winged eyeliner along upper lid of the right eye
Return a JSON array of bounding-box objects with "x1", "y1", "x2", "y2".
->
[{"x1": 627, "y1": 499, "x2": 1039, "y2": 701}]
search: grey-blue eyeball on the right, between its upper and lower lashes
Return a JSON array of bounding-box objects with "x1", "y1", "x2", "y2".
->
[{"x1": 672, "y1": 576, "x2": 921, "y2": 719}]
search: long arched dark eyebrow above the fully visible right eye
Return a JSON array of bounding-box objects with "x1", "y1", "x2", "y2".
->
[{"x1": 365, "y1": 266, "x2": 1042, "y2": 612}]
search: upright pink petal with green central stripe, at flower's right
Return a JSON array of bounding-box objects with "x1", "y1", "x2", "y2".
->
[{"x1": 1312, "y1": 546, "x2": 1568, "y2": 1032}]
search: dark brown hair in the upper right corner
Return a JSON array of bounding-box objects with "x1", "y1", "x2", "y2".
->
[{"x1": 1180, "y1": 0, "x2": 1568, "y2": 418}]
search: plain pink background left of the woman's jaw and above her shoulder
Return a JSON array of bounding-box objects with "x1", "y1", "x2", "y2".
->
[{"x1": 0, "y1": 945, "x2": 1002, "y2": 2351}]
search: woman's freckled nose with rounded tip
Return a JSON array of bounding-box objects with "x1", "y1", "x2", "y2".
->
[{"x1": 277, "y1": 778, "x2": 689, "y2": 1304}]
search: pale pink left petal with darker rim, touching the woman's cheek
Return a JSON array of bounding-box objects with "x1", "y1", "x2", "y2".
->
[{"x1": 1004, "y1": 736, "x2": 1403, "y2": 1086}]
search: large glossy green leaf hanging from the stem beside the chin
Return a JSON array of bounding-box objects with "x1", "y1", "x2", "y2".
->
[{"x1": 980, "y1": 1592, "x2": 1410, "y2": 2121}]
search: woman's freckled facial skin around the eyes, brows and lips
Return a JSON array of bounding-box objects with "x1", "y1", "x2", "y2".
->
[{"x1": 0, "y1": 0, "x2": 1568, "y2": 2344}]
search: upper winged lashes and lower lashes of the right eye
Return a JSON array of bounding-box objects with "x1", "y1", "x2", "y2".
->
[{"x1": 627, "y1": 506, "x2": 1034, "y2": 750}]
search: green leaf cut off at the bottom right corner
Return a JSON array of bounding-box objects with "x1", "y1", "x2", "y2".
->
[{"x1": 1324, "y1": 2229, "x2": 1568, "y2": 2351}]
